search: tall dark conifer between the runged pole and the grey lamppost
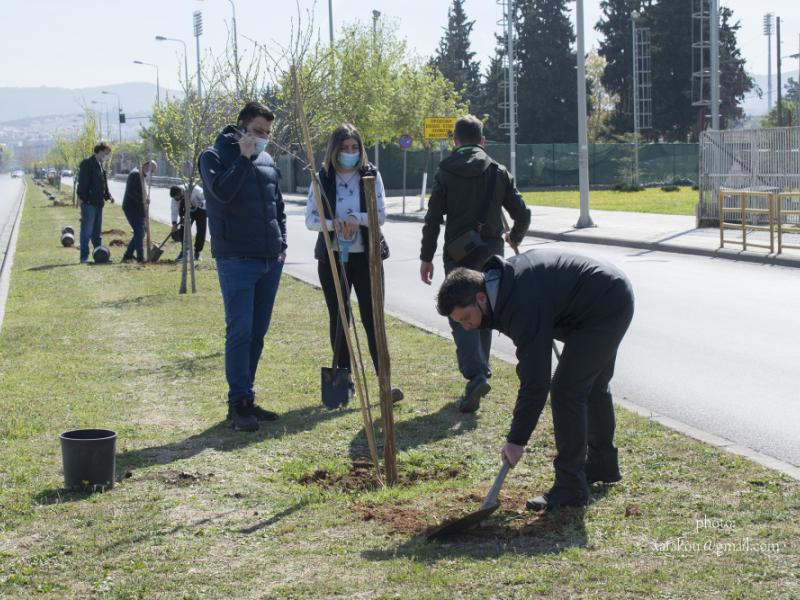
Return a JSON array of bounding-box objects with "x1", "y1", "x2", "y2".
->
[{"x1": 515, "y1": 0, "x2": 578, "y2": 144}]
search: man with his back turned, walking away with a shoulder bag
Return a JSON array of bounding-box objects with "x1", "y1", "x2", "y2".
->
[{"x1": 420, "y1": 115, "x2": 531, "y2": 412}]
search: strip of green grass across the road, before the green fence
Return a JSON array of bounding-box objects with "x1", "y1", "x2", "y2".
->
[{"x1": 522, "y1": 187, "x2": 697, "y2": 215}]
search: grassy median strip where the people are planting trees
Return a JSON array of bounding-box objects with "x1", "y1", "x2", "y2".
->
[{"x1": 0, "y1": 180, "x2": 800, "y2": 599}]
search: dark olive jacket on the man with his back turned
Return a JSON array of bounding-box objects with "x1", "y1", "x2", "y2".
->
[{"x1": 420, "y1": 146, "x2": 531, "y2": 262}]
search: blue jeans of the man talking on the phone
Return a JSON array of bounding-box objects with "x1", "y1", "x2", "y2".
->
[{"x1": 217, "y1": 257, "x2": 283, "y2": 406}]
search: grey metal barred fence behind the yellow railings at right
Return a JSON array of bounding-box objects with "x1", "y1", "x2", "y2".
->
[{"x1": 697, "y1": 127, "x2": 800, "y2": 227}]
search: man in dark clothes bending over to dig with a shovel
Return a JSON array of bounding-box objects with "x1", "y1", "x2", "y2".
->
[{"x1": 437, "y1": 249, "x2": 634, "y2": 510}]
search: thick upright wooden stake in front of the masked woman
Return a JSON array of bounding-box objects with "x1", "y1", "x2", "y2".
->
[{"x1": 362, "y1": 175, "x2": 397, "y2": 485}]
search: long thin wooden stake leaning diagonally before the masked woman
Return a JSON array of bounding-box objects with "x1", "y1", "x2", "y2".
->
[{"x1": 291, "y1": 66, "x2": 383, "y2": 485}]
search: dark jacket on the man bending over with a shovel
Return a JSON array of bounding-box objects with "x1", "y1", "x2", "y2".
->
[{"x1": 484, "y1": 248, "x2": 633, "y2": 446}]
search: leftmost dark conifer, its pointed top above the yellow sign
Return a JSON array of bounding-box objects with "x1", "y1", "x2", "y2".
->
[{"x1": 431, "y1": 0, "x2": 481, "y2": 107}]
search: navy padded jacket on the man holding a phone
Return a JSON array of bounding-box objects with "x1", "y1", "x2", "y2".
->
[{"x1": 199, "y1": 125, "x2": 286, "y2": 258}]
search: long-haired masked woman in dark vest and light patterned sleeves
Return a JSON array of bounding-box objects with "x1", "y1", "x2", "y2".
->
[{"x1": 306, "y1": 123, "x2": 403, "y2": 402}]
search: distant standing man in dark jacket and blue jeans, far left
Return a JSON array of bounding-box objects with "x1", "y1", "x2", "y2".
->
[{"x1": 76, "y1": 142, "x2": 114, "y2": 263}]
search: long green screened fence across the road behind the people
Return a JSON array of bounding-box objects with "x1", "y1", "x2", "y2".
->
[{"x1": 278, "y1": 143, "x2": 698, "y2": 193}]
